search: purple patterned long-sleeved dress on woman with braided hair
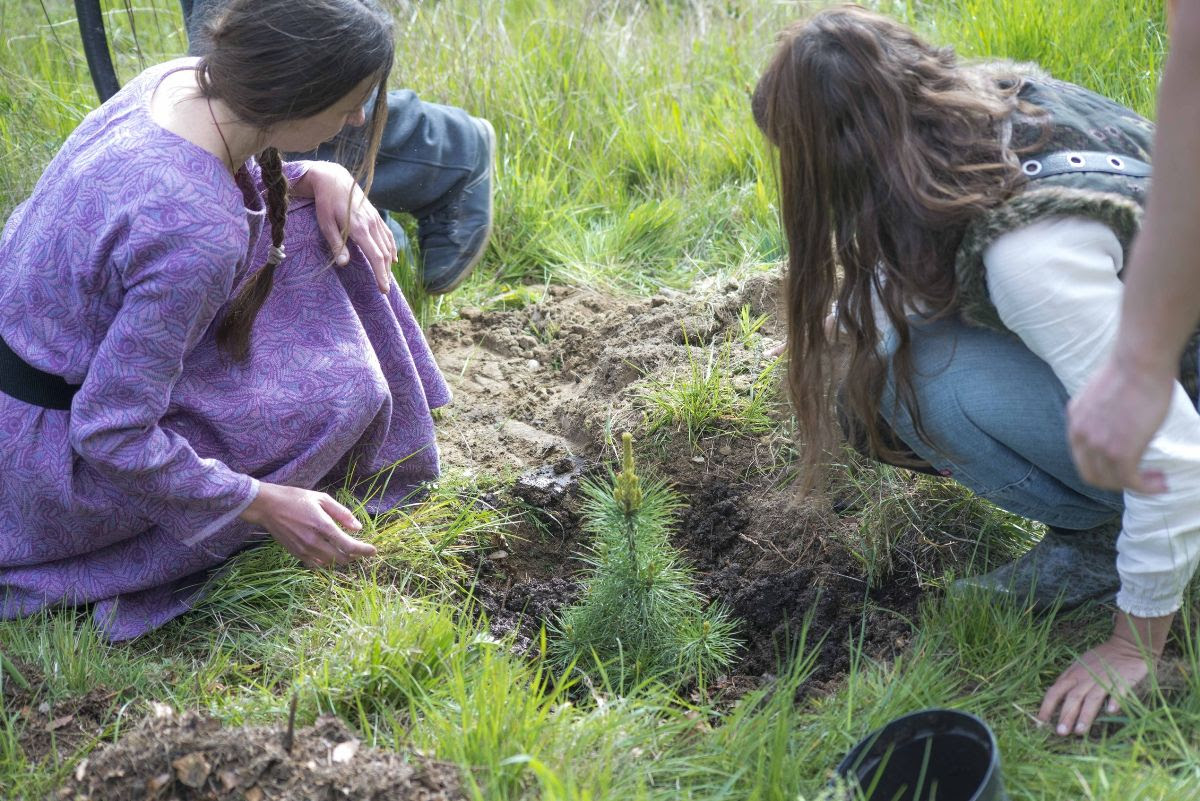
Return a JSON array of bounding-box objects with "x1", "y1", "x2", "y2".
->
[{"x1": 0, "y1": 61, "x2": 450, "y2": 639}]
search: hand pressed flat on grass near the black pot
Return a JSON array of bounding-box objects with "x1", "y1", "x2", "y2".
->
[{"x1": 1038, "y1": 612, "x2": 1175, "y2": 736}]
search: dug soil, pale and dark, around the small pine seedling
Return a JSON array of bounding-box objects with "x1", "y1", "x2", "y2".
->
[{"x1": 430, "y1": 273, "x2": 962, "y2": 695}]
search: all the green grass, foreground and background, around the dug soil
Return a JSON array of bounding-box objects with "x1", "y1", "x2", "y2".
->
[{"x1": 0, "y1": 0, "x2": 1200, "y2": 801}]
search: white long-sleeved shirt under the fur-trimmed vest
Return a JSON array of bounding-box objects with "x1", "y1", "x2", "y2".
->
[{"x1": 984, "y1": 217, "x2": 1200, "y2": 618}]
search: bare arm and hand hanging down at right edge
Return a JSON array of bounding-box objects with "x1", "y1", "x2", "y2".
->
[{"x1": 1069, "y1": 0, "x2": 1200, "y2": 492}]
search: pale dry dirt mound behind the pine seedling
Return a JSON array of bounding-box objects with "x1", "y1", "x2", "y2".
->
[{"x1": 430, "y1": 275, "x2": 778, "y2": 475}]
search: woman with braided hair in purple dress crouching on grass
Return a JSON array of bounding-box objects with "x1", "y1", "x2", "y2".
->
[{"x1": 0, "y1": 0, "x2": 449, "y2": 639}]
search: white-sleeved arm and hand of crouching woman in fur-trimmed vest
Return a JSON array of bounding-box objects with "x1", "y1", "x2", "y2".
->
[{"x1": 984, "y1": 217, "x2": 1200, "y2": 734}]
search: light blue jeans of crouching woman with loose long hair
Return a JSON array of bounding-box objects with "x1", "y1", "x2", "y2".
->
[{"x1": 880, "y1": 319, "x2": 1124, "y2": 529}]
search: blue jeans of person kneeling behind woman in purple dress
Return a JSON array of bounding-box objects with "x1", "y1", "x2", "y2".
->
[{"x1": 186, "y1": 0, "x2": 486, "y2": 218}]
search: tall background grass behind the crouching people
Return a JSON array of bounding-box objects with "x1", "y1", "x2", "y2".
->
[{"x1": 0, "y1": 0, "x2": 1164, "y2": 291}]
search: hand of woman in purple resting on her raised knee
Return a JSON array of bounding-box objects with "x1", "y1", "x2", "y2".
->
[{"x1": 292, "y1": 162, "x2": 396, "y2": 293}]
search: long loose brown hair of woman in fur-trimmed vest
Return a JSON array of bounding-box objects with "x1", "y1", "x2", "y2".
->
[{"x1": 754, "y1": 6, "x2": 1036, "y2": 489}]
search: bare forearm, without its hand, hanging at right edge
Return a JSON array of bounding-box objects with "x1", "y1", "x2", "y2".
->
[{"x1": 1114, "y1": 0, "x2": 1200, "y2": 378}]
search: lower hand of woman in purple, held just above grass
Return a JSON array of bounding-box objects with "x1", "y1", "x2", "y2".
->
[{"x1": 240, "y1": 481, "x2": 376, "y2": 567}]
